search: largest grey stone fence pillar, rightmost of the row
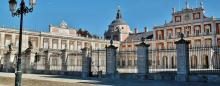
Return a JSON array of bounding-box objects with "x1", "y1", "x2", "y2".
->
[{"x1": 175, "y1": 34, "x2": 189, "y2": 81}]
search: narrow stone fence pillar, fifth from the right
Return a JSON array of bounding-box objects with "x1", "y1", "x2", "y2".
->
[{"x1": 61, "y1": 49, "x2": 68, "y2": 75}]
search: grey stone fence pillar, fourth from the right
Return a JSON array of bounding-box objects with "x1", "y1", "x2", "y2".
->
[{"x1": 82, "y1": 48, "x2": 91, "y2": 79}]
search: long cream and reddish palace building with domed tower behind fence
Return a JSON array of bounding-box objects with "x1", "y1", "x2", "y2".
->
[{"x1": 0, "y1": 2, "x2": 220, "y2": 71}]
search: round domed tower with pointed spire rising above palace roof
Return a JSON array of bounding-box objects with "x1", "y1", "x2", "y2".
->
[{"x1": 104, "y1": 8, "x2": 131, "y2": 41}]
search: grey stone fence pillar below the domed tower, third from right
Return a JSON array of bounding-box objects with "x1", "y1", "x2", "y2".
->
[{"x1": 106, "y1": 40, "x2": 118, "y2": 79}]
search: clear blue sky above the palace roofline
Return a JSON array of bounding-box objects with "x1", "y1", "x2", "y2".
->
[{"x1": 0, "y1": 0, "x2": 220, "y2": 36}]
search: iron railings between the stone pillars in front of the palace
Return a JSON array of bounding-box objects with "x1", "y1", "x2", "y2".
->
[{"x1": 30, "y1": 46, "x2": 220, "y2": 74}]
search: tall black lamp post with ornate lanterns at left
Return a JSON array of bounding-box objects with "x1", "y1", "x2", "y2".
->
[{"x1": 9, "y1": 0, "x2": 36, "y2": 86}]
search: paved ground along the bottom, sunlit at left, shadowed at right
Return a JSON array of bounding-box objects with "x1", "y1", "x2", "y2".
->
[{"x1": 0, "y1": 72, "x2": 220, "y2": 86}]
